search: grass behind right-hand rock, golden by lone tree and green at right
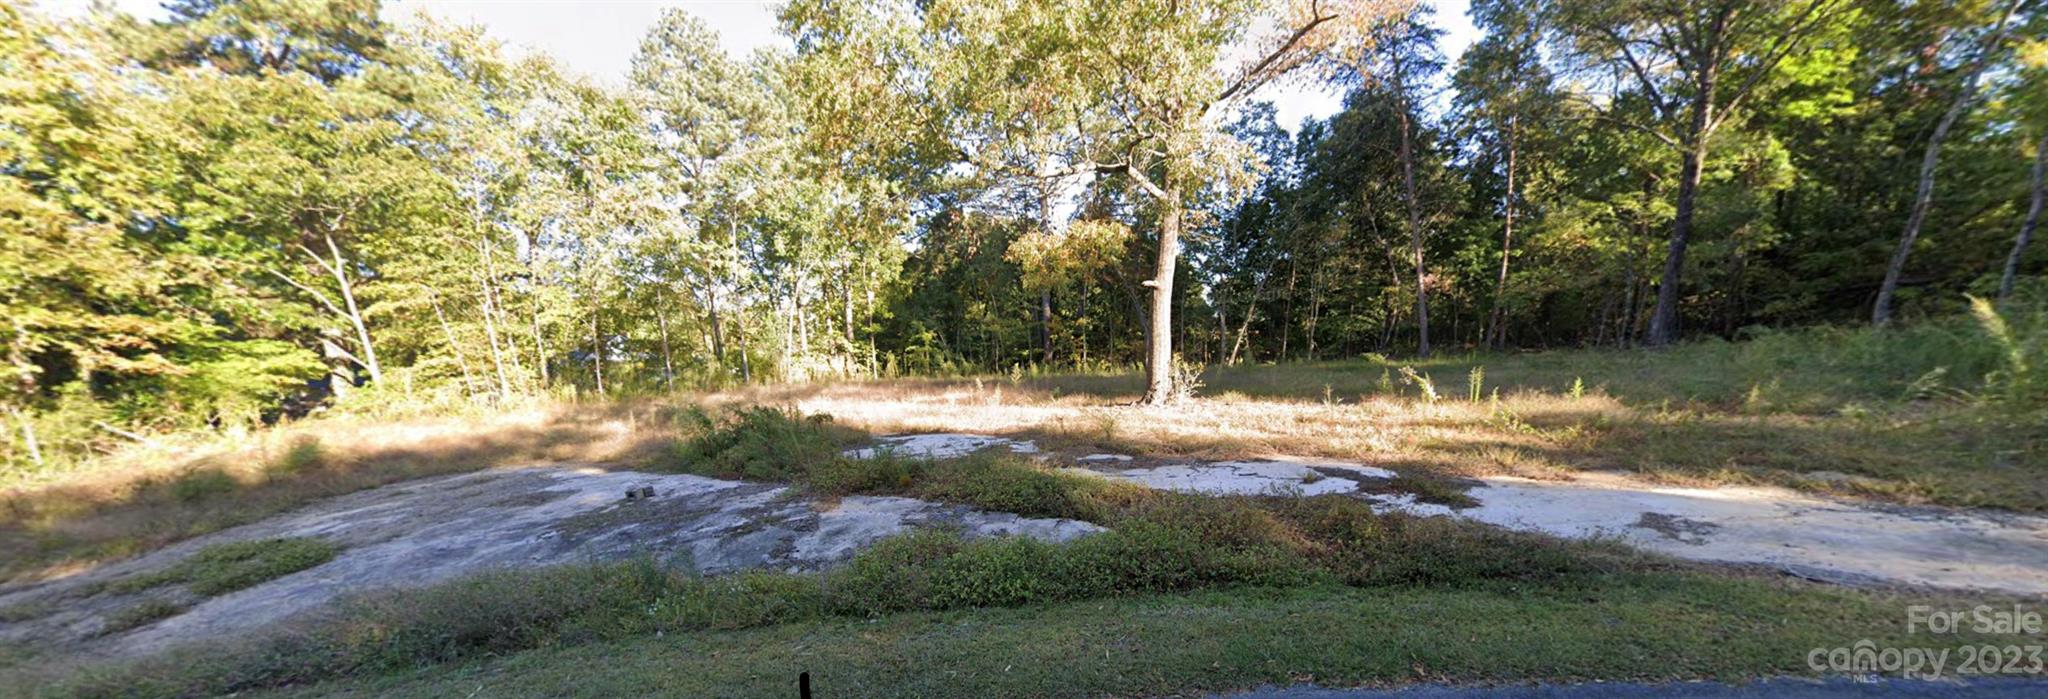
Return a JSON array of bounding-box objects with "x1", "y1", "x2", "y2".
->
[{"x1": 765, "y1": 326, "x2": 2048, "y2": 512}]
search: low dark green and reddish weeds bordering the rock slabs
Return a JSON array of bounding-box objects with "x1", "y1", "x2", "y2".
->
[{"x1": 28, "y1": 408, "x2": 1630, "y2": 695}]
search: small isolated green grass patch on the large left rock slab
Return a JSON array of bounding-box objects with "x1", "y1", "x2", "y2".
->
[{"x1": 106, "y1": 537, "x2": 342, "y2": 597}]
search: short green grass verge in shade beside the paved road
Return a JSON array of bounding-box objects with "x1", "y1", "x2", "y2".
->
[{"x1": 247, "y1": 574, "x2": 2011, "y2": 697}]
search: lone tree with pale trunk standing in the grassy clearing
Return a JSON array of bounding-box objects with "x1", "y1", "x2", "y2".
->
[{"x1": 937, "y1": 0, "x2": 1407, "y2": 404}]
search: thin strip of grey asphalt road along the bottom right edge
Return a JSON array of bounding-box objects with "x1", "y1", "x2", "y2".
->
[{"x1": 1219, "y1": 676, "x2": 2048, "y2": 699}]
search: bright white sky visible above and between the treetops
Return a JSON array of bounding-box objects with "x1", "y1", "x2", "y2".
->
[{"x1": 41, "y1": 0, "x2": 1479, "y2": 129}]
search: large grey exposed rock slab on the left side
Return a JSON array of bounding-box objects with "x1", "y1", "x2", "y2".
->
[{"x1": 0, "y1": 465, "x2": 1100, "y2": 654}]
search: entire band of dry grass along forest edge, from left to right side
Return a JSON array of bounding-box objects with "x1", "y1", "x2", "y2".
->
[{"x1": 0, "y1": 346, "x2": 2048, "y2": 580}]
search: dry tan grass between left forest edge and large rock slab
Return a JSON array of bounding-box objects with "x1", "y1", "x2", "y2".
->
[{"x1": 0, "y1": 402, "x2": 692, "y2": 580}]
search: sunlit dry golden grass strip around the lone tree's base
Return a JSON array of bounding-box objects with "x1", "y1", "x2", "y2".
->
[{"x1": 707, "y1": 355, "x2": 2048, "y2": 510}]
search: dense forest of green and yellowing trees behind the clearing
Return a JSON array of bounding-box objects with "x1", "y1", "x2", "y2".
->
[{"x1": 12, "y1": 0, "x2": 2048, "y2": 471}]
